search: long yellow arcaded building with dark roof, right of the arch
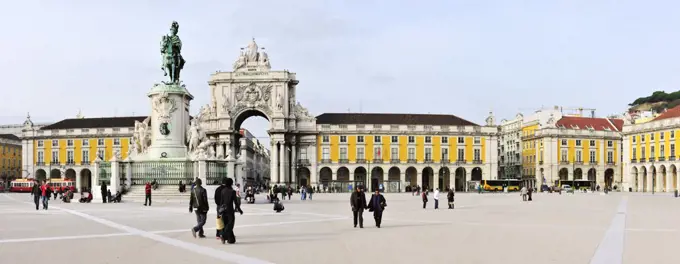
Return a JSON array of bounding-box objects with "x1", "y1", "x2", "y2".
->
[{"x1": 316, "y1": 113, "x2": 498, "y2": 191}]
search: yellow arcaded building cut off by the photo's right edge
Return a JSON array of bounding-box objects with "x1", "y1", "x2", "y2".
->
[{"x1": 623, "y1": 107, "x2": 680, "y2": 192}]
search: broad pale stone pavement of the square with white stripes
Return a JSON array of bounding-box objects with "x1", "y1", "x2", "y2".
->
[{"x1": 0, "y1": 193, "x2": 680, "y2": 264}]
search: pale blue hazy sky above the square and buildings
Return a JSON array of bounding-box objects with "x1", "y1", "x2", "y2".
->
[{"x1": 0, "y1": 0, "x2": 680, "y2": 144}]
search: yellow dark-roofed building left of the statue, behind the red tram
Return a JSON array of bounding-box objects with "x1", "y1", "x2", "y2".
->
[{"x1": 22, "y1": 116, "x2": 146, "y2": 190}]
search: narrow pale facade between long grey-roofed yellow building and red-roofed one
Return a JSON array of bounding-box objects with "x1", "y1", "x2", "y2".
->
[{"x1": 498, "y1": 114, "x2": 524, "y2": 179}]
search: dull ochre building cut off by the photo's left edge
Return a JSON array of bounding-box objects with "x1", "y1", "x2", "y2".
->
[{"x1": 0, "y1": 134, "x2": 21, "y2": 182}]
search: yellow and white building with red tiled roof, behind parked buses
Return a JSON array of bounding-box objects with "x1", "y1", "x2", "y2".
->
[{"x1": 524, "y1": 116, "x2": 623, "y2": 189}]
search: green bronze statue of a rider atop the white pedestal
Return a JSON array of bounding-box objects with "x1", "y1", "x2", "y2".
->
[{"x1": 161, "y1": 21, "x2": 185, "y2": 83}]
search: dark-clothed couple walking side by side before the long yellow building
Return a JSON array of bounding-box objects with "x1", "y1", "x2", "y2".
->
[{"x1": 349, "y1": 186, "x2": 387, "y2": 228}]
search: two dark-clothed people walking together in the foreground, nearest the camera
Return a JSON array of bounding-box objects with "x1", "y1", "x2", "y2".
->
[{"x1": 189, "y1": 178, "x2": 243, "y2": 244}]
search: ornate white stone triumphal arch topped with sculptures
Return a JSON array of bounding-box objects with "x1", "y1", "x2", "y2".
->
[{"x1": 196, "y1": 39, "x2": 318, "y2": 185}]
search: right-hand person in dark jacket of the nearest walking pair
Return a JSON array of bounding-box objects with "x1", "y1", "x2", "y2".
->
[{"x1": 218, "y1": 178, "x2": 243, "y2": 244}]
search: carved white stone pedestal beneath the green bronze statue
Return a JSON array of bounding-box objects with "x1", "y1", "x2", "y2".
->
[{"x1": 141, "y1": 83, "x2": 194, "y2": 160}]
